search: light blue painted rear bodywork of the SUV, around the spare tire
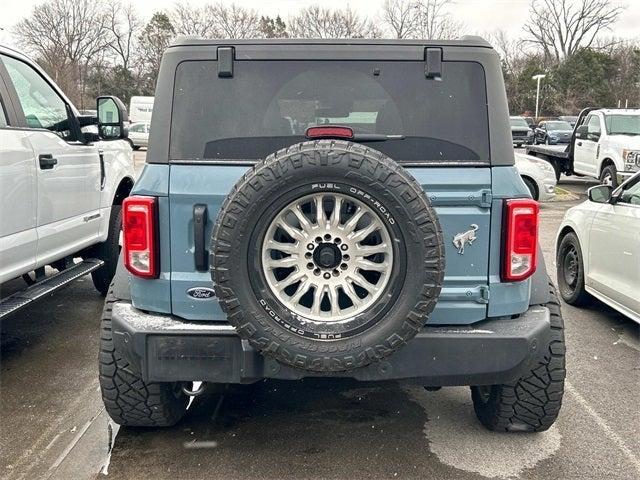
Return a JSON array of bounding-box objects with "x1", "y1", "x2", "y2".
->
[{"x1": 131, "y1": 165, "x2": 530, "y2": 325}]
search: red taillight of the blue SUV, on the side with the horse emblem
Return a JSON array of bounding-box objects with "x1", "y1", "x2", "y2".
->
[{"x1": 502, "y1": 199, "x2": 539, "y2": 282}]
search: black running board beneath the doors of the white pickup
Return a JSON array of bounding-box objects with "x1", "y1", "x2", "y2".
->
[{"x1": 0, "y1": 258, "x2": 104, "y2": 320}]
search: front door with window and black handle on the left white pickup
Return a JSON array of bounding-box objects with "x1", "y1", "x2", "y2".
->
[{"x1": 2, "y1": 55, "x2": 101, "y2": 266}]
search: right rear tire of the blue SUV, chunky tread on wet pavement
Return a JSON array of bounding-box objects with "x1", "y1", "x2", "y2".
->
[{"x1": 471, "y1": 282, "x2": 566, "y2": 432}]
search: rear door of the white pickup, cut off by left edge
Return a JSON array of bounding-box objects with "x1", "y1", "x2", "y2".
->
[{"x1": 0, "y1": 78, "x2": 38, "y2": 284}]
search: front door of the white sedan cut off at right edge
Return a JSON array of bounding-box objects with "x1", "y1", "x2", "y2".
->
[{"x1": 587, "y1": 177, "x2": 640, "y2": 315}]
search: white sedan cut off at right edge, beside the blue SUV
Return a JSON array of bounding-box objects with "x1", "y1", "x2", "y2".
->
[{"x1": 556, "y1": 173, "x2": 640, "y2": 322}]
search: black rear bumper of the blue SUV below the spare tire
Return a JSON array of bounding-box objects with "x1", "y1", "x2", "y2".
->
[{"x1": 112, "y1": 302, "x2": 550, "y2": 386}]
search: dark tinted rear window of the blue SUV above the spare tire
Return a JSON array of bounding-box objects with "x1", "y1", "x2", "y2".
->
[{"x1": 170, "y1": 60, "x2": 489, "y2": 163}]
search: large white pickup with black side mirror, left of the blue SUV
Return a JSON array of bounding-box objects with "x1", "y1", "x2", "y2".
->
[{"x1": 0, "y1": 46, "x2": 134, "y2": 319}]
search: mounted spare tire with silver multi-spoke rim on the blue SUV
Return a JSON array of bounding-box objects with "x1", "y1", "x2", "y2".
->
[{"x1": 210, "y1": 140, "x2": 444, "y2": 372}]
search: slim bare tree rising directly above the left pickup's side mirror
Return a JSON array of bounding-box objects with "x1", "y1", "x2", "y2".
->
[{"x1": 107, "y1": 2, "x2": 142, "y2": 70}]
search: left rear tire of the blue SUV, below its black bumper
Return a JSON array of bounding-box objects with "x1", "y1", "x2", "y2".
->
[{"x1": 98, "y1": 290, "x2": 189, "y2": 427}]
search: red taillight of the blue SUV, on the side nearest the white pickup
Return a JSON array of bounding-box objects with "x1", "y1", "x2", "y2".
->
[{"x1": 122, "y1": 196, "x2": 158, "y2": 278}]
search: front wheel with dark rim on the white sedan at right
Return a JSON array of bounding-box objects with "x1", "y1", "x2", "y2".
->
[{"x1": 556, "y1": 232, "x2": 590, "y2": 307}]
